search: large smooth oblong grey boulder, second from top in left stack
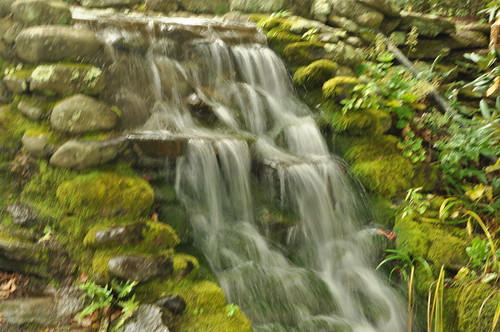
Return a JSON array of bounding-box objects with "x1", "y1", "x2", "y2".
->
[{"x1": 15, "y1": 25, "x2": 101, "y2": 63}]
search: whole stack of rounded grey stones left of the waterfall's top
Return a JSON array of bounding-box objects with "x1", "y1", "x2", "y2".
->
[{"x1": 0, "y1": 0, "x2": 132, "y2": 169}]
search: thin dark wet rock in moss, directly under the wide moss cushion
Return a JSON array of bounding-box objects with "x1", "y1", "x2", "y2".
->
[{"x1": 84, "y1": 223, "x2": 146, "y2": 246}]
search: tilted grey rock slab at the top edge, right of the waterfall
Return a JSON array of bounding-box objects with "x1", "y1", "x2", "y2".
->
[{"x1": 332, "y1": 0, "x2": 384, "y2": 29}]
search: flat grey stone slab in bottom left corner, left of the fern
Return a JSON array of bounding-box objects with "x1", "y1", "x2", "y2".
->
[{"x1": 0, "y1": 295, "x2": 83, "y2": 326}]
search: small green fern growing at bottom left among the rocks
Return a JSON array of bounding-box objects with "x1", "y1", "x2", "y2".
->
[{"x1": 76, "y1": 279, "x2": 139, "y2": 331}]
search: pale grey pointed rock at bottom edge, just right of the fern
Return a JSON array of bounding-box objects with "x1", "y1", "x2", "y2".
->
[{"x1": 118, "y1": 304, "x2": 170, "y2": 332}]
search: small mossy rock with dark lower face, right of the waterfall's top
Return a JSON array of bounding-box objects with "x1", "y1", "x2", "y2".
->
[{"x1": 293, "y1": 59, "x2": 338, "y2": 89}]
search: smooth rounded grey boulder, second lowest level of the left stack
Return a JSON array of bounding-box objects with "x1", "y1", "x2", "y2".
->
[{"x1": 50, "y1": 95, "x2": 119, "y2": 133}]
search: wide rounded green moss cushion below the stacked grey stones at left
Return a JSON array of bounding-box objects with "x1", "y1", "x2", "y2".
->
[{"x1": 56, "y1": 171, "x2": 154, "y2": 216}]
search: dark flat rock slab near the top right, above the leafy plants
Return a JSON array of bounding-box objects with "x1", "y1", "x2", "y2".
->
[{"x1": 398, "y1": 11, "x2": 456, "y2": 38}]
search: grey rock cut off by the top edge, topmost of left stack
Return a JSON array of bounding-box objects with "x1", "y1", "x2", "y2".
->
[{"x1": 11, "y1": 0, "x2": 73, "y2": 26}]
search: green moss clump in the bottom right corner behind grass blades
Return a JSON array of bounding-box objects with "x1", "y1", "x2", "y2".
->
[{"x1": 458, "y1": 283, "x2": 500, "y2": 332}]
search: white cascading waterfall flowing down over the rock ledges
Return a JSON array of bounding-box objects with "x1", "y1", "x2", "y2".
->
[{"x1": 75, "y1": 8, "x2": 405, "y2": 332}]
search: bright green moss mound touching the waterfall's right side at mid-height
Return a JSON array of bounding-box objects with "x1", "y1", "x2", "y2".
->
[{"x1": 351, "y1": 155, "x2": 414, "y2": 198}]
